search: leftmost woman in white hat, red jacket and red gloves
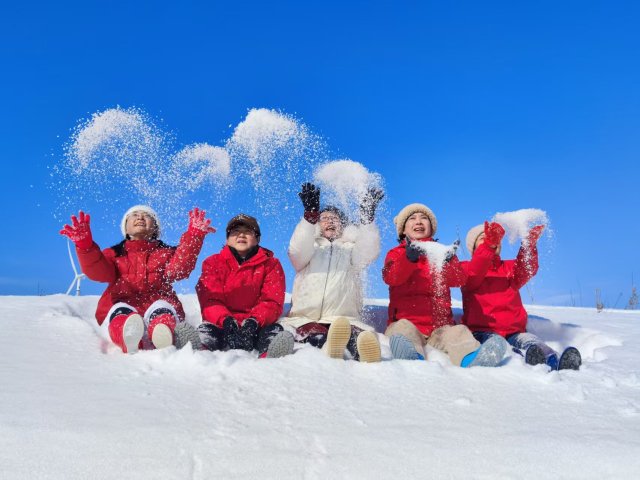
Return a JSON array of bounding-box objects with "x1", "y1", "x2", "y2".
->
[{"x1": 60, "y1": 205, "x2": 215, "y2": 353}]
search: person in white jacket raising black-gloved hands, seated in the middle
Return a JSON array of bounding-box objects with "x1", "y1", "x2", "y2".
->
[{"x1": 280, "y1": 183, "x2": 384, "y2": 362}]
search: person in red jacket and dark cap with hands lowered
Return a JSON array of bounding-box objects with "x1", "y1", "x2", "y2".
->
[{"x1": 196, "y1": 213, "x2": 286, "y2": 354}]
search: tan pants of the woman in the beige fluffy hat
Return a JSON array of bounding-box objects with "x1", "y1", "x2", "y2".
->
[{"x1": 384, "y1": 319, "x2": 480, "y2": 365}]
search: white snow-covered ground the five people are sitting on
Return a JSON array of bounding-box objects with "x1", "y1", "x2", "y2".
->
[{"x1": 0, "y1": 295, "x2": 640, "y2": 479}]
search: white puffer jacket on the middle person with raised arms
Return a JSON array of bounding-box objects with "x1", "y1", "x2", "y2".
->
[{"x1": 280, "y1": 219, "x2": 380, "y2": 330}]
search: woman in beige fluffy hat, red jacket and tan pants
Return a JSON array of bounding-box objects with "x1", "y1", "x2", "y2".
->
[{"x1": 382, "y1": 203, "x2": 506, "y2": 367}]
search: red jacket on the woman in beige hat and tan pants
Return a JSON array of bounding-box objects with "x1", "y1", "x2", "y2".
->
[{"x1": 382, "y1": 239, "x2": 493, "y2": 336}]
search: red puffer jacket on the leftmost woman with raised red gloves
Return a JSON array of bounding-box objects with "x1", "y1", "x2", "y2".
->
[{"x1": 76, "y1": 232, "x2": 204, "y2": 324}]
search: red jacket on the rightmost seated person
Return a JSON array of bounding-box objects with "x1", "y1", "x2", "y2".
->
[{"x1": 461, "y1": 242, "x2": 538, "y2": 336}]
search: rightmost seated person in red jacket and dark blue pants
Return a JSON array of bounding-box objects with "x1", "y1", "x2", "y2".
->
[{"x1": 461, "y1": 222, "x2": 582, "y2": 370}]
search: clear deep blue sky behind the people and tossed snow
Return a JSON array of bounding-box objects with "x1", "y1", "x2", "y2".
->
[{"x1": 0, "y1": 1, "x2": 640, "y2": 307}]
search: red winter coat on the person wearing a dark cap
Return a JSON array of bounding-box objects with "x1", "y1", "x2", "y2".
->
[{"x1": 196, "y1": 246, "x2": 285, "y2": 327}]
